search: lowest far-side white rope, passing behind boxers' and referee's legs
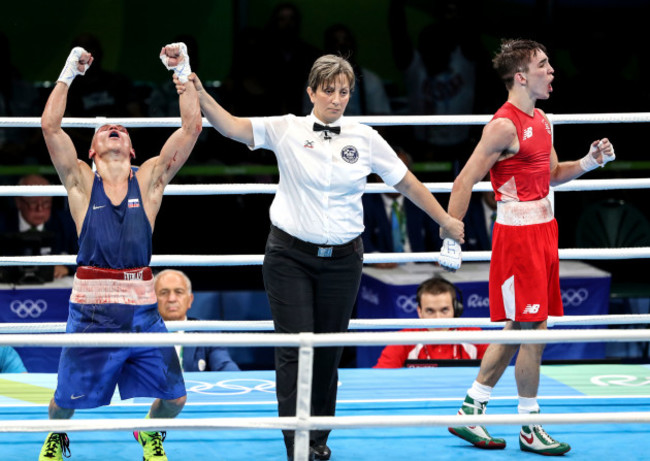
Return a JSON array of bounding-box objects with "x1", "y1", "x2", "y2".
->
[{"x1": 0, "y1": 314, "x2": 650, "y2": 334}]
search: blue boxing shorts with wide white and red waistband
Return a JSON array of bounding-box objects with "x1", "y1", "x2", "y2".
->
[{"x1": 54, "y1": 267, "x2": 186, "y2": 409}]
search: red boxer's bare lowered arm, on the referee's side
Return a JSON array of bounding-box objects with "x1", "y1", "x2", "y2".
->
[{"x1": 449, "y1": 118, "x2": 519, "y2": 219}]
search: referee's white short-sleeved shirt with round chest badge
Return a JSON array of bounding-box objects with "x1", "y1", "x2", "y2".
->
[{"x1": 249, "y1": 112, "x2": 407, "y2": 245}]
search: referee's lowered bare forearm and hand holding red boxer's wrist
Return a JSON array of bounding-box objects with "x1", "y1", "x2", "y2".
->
[{"x1": 395, "y1": 171, "x2": 465, "y2": 242}]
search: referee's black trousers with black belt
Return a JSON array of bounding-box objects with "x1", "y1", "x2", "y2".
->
[{"x1": 262, "y1": 228, "x2": 363, "y2": 449}]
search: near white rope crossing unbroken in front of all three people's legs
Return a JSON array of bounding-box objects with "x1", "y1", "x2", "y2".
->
[{"x1": 0, "y1": 329, "x2": 650, "y2": 348}]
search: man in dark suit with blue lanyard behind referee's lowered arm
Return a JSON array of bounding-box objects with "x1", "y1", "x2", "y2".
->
[{"x1": 362, "y1": 146, "x2": 442, "y2": 268}]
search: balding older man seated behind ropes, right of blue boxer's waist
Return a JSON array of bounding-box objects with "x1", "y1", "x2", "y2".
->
[{"x1": 154, "y1": 269, "x2": 239, "y2": 371}]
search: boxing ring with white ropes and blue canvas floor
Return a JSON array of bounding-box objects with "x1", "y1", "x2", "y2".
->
[{"x1": 0, "y1": 113, "x2": 650, "y2": 461}]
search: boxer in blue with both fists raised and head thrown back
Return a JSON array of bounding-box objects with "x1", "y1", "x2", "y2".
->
[{"x1": 39, "y1": 43, "x2": 201, "y2": 461}]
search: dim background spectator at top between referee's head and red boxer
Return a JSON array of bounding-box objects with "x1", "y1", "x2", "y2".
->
[{"x1": 389, "y1": 0, "x2": 480, "y2": 159}]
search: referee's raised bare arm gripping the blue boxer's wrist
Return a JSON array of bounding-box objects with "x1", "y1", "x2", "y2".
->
[{"x1": 184, "y1": 74, "x2": 253, "y2": 146}]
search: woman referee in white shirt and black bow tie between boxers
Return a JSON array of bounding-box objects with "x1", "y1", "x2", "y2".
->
[{"x1": 177, "y1": 55, "x2": 463, "y2": 460}]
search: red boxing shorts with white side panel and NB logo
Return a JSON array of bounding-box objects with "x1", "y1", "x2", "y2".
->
[{"x1": 490, "y1": 202, "x2": 564, "y2": 322}]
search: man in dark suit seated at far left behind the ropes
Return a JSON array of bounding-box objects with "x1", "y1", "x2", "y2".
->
[{"x1": 0, "y1": 174, "x2": 79, "y2": 278}]
